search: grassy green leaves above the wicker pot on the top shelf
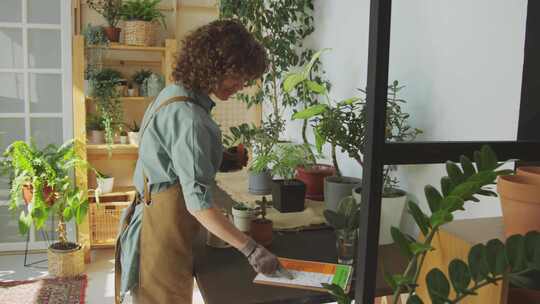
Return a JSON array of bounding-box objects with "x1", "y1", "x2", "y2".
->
[{"x1": 120, "y1": 0, "x2": 167, "y2": 28}]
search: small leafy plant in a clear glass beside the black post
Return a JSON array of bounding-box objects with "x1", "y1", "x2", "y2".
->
[{"x1": 324, "y1": 196, "x2": 360, "y2": 265}]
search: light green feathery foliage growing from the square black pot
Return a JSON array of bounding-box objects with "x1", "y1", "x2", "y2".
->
[{"x1": 271, "y1": 144, "x2": 315, "y2": 181}]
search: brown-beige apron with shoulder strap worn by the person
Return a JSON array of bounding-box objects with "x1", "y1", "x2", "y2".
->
[{"x1": 115, "y1": 96, "x2": 199, "y2": 304}]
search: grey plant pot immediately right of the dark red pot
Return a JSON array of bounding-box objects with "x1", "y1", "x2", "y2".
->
[{"x1": 324, "y1": 176, "x2": 362, "y2": 211}]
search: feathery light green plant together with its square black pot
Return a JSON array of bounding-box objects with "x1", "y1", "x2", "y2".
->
[{"x1": 271, "y1": 144, "x2": 315, "y2": 212}]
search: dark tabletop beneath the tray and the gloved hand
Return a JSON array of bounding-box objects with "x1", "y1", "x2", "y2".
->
[{"x1": 194, "y1": 229, "x2": 406, "y2": 304}]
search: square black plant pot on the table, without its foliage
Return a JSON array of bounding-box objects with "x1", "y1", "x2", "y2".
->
[{"x1": 272, "y1": 179, "x2": 306, "y2": 213}]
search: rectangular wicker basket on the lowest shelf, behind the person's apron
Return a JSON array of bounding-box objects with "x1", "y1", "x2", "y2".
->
[{"x1": 90, "y1": 202, "x2": 130, "y2": 246}]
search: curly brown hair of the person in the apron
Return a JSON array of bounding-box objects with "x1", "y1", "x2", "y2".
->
[{"x1": 173, "y1": 20, "x2": 268, "y2": 94}]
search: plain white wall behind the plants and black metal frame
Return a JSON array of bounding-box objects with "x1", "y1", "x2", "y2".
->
[{"x1": 268, "y1": 0, "x2": 527, "y2": 233}]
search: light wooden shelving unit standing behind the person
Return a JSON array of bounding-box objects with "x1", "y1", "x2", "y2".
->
[{"x1": 73, "y1": 36, "x2": 176, "y2": 255}]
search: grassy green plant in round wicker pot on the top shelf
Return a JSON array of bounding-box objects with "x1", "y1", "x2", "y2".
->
[{"x1": 120, "y1": 0, "x2": 166, "y2": 46}]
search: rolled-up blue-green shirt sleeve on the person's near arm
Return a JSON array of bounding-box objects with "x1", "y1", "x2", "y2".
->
[{"x1": 171, "y1": 121, "x2": 216, "y2": 213}]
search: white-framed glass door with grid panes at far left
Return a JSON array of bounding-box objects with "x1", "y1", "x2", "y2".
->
[{"x1": 0, "y1": 0, "x2": 73, "y2": 251}]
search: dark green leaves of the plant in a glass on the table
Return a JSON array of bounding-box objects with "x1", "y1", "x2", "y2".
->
[{"x1": 323, "y1": 196, "x2": 360, "y2": 231}]
